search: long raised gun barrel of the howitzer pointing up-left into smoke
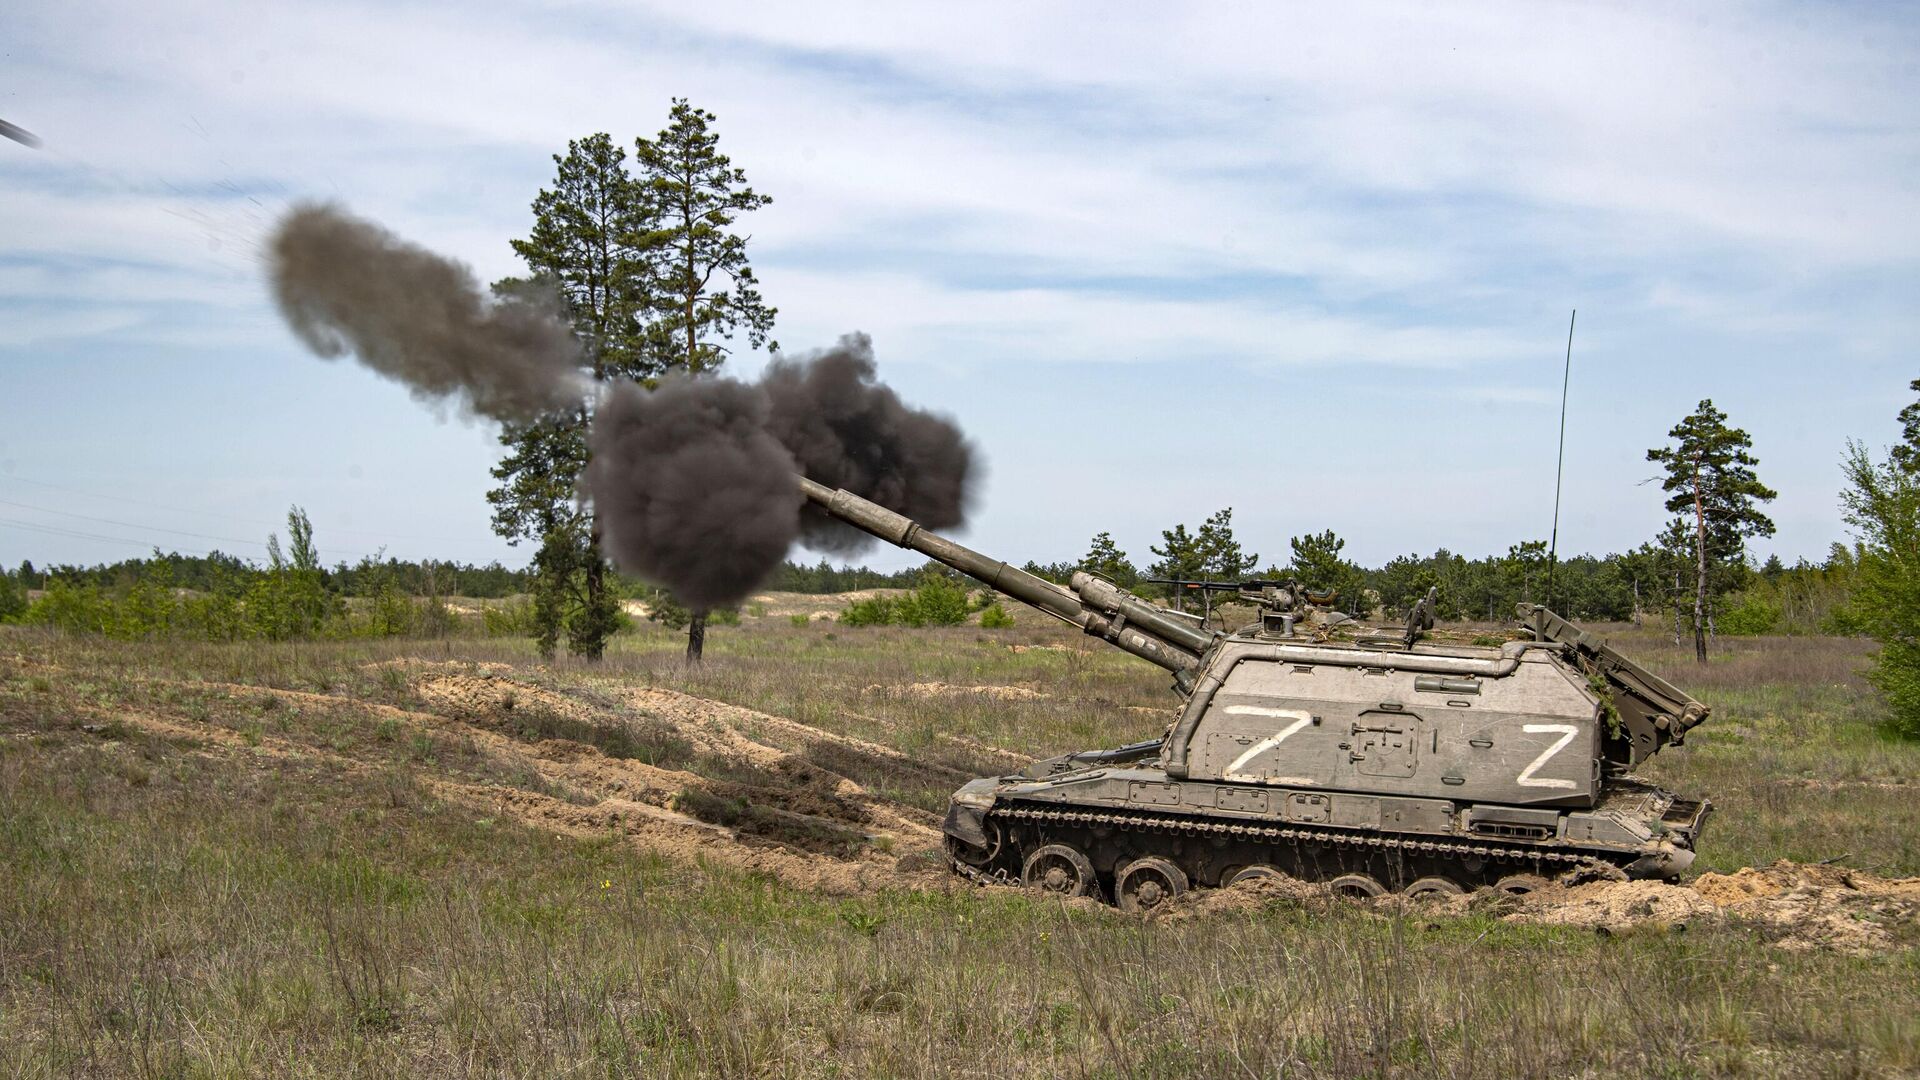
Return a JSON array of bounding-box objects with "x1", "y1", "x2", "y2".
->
[{"x1": 799, "y1": 477, "x2": 1212, "y2": 680}]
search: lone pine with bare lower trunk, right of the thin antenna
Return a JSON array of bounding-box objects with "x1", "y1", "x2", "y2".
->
[{"x1": 1647, "y1": 400, "x2": 1778, "y2": 663}]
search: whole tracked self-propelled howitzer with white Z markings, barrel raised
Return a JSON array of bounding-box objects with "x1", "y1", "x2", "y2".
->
[{"x1": 801, "y1": 479, "x2": 1707, "y2": 909}]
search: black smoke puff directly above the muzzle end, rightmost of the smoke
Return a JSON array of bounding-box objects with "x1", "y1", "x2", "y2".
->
[{"x1": 760, "y1": 334, "x2": 973, "y2": 553}]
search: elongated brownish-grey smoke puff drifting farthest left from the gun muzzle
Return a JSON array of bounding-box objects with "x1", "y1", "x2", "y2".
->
[{"x1": 271, "y1": 204, "x2": 584, "y2": 421}]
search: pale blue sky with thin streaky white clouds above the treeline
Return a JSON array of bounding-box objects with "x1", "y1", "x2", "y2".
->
[{"x1": 0, "y1": 0, "x2": 1920, "y2": 569}]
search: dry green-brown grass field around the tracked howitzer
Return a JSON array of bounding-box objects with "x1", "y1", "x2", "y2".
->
[{"x1": 0, "y1": 617, "x2": 1920, "y2": 1078}]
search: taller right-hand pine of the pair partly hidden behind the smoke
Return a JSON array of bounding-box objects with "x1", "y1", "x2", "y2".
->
[{"x1": 634, "y1": 98, "x2": 780, "y2": 661}]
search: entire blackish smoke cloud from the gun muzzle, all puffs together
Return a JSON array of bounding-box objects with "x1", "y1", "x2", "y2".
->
[{"x1": 271, "y1": 206, "x2": 973, "y2": 607}]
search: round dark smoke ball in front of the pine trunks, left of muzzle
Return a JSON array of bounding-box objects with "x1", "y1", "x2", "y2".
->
[{"x1": 584, "y1": 375, "x2": 801, "y2": 609}]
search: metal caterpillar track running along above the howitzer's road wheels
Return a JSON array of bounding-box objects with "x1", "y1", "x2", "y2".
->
[{"x1": 948, "y1": 803, "x2": 1632, "y2": 884}]
